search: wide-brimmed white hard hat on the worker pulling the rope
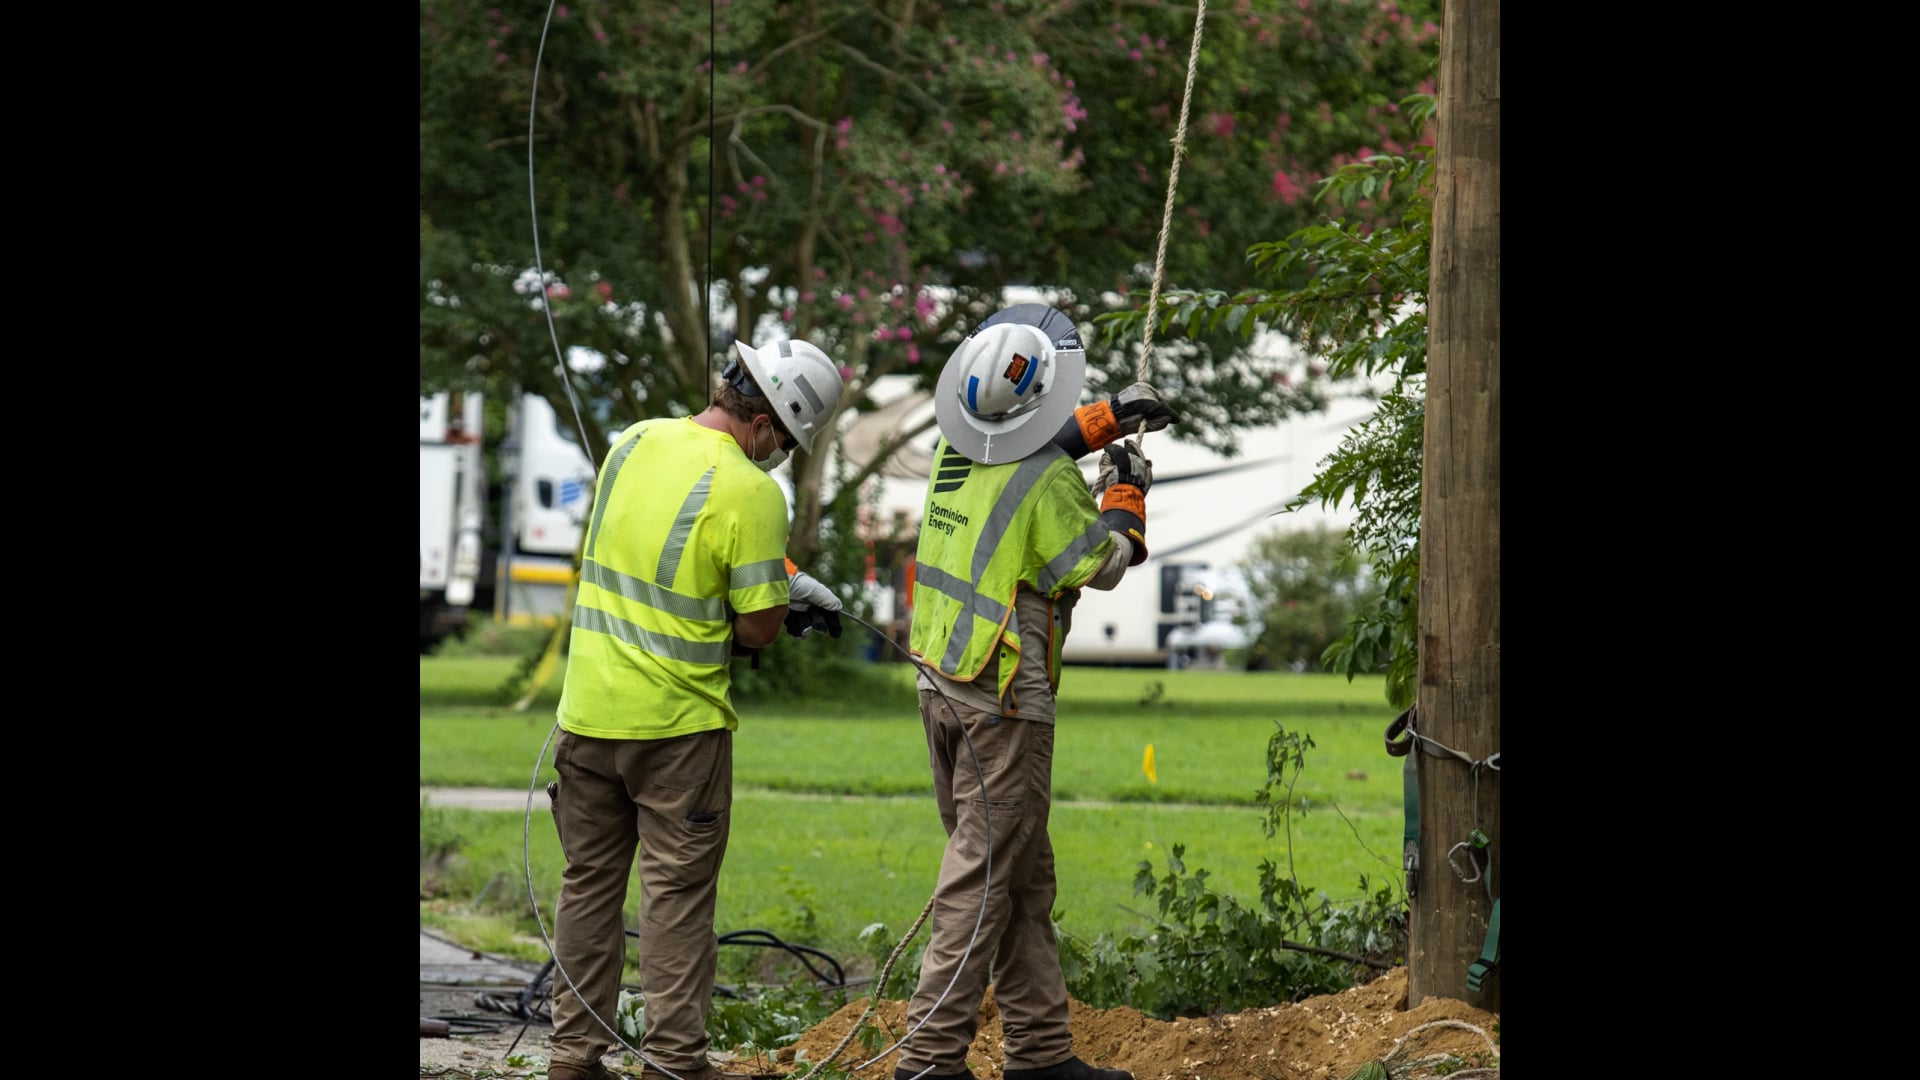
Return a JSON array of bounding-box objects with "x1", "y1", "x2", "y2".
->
[{"x1": 933, "y1": 304, "x2": 1087, "y2": 465}]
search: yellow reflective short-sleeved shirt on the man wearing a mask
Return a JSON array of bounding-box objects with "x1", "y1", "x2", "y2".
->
[{"x1": 559, "y1": 417, "x2": 787, "y2": 738}]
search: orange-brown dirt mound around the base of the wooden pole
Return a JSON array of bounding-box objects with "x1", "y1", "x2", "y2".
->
[{"x1": 781, "y1": 967, "x2": 1500, "y2": 1080}]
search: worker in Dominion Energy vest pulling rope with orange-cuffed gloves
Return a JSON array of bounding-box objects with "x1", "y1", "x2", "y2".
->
[{"x1": 893, "y1": 304, "x2": 1177, "y2": 1080}]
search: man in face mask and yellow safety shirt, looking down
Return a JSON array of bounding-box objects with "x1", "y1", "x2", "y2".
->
[{"x1": 547, "y1": 342, "x2": 841, "y2": 1080}]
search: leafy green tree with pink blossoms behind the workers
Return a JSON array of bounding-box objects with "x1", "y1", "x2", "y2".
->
[{"x1": 420, "y1": 0, "x2": 1436, "y2": 557}]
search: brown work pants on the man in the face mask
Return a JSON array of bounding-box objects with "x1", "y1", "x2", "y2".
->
[{"x1": 551, "y1": 730, "x2": 733, "y2": 1072}]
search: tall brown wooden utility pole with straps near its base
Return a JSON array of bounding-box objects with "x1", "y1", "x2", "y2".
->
[{"x1": 1407, "y1": 0, "x2": 1503, "y2": 1013}]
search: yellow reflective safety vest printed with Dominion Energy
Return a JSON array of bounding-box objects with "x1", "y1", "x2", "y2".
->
[{"x1": 908, "y1": 438, "x2": 1114, "y2": 698}]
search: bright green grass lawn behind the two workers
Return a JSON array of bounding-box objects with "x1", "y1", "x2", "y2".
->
[{"x1": 420, "y1": 657, "x2": 1402, "y2": 963}]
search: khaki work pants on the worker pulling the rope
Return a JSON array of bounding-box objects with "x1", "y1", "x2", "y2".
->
[{"x1": 897, "y1": 690, "x2": 1073, "y2": 1074}]
